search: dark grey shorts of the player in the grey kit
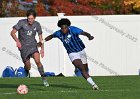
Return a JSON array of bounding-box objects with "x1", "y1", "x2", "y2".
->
[{"x1": 20, "y1": 46, "x2": 39, "y2": 61}]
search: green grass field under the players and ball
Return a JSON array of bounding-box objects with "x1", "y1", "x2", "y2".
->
[{"x1": 0, "y1": 76, "x2": 140, "y2": 99}]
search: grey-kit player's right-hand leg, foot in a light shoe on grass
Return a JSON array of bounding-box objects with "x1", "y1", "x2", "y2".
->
[{"x1": 33, "y1": 52, "x2": 49, "y2": 87}]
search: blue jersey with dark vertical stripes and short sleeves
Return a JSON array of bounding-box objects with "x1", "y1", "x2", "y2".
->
[{"x1": 53, "y1": 26, "x2": 85, "y2": 54}]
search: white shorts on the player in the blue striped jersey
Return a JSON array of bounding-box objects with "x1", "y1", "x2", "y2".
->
[{"x1": 69, "y1": 50, "x2": 87, "y2": 64}]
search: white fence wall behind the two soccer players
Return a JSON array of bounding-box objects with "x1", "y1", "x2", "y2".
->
[{"x1": 0, "y1": 15, "x2": 140, "y2": 77}]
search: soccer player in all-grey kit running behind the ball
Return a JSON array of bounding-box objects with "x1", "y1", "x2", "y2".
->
[{"x1": 11, "y1": 10, "x2": 49, "y2": 86}]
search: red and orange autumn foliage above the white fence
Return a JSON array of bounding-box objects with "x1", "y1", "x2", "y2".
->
[{"x1": 0, "y1": 0, "x2": 140, "y2": 17}]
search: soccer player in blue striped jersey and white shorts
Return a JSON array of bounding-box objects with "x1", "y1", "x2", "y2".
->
[{"x1": 38, "y1": 18, "x2": 99, "y2": 90}]
